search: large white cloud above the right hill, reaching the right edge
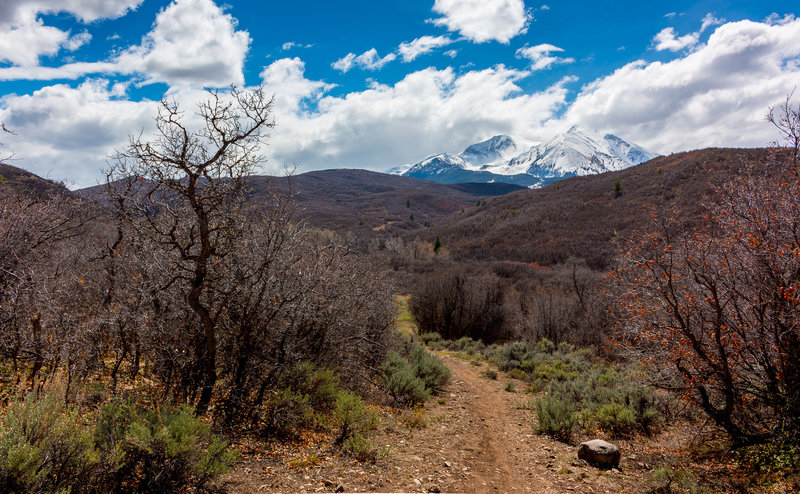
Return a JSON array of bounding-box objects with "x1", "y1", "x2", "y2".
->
[{"x1": 566, "y1": 19, "x2": 800, "y2": 152}]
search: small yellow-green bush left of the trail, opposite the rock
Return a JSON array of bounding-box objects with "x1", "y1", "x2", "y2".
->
[{"x1": 333, "y1": 391, "x2": 378, "y2": 461}]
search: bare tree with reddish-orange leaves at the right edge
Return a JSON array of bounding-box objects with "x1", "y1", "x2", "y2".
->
[{"x1": 615, "y1": 94, "x2": 800, "y2": 446}]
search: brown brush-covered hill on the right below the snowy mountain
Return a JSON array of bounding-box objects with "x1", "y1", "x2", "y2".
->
[{"x1": 428, "y1": 149, "x2": 768, "y2": 268}]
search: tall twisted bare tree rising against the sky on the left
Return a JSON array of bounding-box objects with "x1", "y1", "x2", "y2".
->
[{"x1": 107, "y1": 88, "x2": 274, "y2": 413}]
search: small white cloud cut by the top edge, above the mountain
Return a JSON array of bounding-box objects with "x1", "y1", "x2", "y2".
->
[{"x1": 433, "y1": 0, "x2": 531, "y2": 43}]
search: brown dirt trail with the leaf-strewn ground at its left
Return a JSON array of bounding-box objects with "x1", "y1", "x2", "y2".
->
[{"x1": 220, "y1": 356, "x2": 643, "y2": 494}]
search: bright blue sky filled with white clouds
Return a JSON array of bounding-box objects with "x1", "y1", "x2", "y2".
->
[{"x1": 0, "y1": 0, "x2": 800, "y2": 188}]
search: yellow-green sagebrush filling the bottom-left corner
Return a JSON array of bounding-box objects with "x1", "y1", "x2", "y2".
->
[{"x1": 0, "y1": 395, "x2": 100, "y2": 492}]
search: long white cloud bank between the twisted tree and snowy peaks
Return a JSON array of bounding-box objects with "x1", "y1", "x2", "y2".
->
[{"x1": 262, "y1": 58, "x2": 571, "y2": 171}]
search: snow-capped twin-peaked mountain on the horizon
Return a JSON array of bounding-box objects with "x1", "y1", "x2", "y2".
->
[{"x1": 388, "y1": 126, "x2": 658, "y2": 187}]
